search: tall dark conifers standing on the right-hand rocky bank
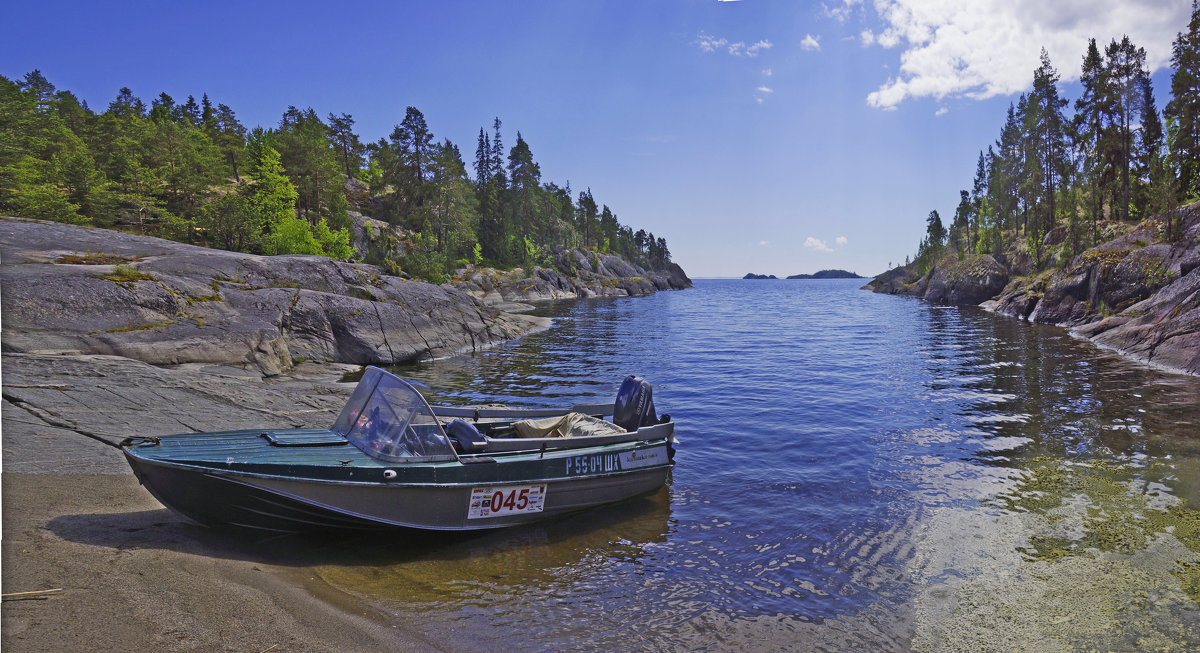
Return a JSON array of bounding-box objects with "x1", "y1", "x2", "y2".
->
[{"x1": 916, "y1": 0, "x2": 1200, "y2": 271}]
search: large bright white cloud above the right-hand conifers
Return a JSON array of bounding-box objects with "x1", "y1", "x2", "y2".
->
[{"x1": 859, "y1": 0, "x2": 1190, "y2": 109}]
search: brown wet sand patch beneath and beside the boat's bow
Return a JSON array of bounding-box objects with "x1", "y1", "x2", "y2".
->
[{"x1": 0, "y1": 473, "x2": 442, "y2": 651}]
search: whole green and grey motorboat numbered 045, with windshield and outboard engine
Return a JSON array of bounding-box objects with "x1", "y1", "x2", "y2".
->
[{"x1": 120, "y1": 367, "x2": 674, "y2": 532}]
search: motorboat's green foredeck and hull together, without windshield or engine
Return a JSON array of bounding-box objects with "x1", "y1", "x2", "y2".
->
[{"x1": 125, "y1": 430, "x2": 672, "y2": 532}]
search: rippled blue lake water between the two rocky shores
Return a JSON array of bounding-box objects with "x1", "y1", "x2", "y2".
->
[{"x1": 314, "y1": 280, "x2": 1200, "y2": 651}]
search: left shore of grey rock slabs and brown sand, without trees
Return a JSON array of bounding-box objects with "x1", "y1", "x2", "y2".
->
[{"x1": 0, "y1": 218, "x2": 690, "y2": 651}]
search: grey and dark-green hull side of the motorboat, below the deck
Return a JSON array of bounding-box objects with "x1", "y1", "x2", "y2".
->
[{"x1": 126, "y1": 443, "x2": 670, "y2": 532}]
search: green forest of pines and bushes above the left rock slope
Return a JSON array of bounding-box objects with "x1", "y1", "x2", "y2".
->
[{"x1": 0, "y1": 71, "x2": 671, "y2": 278}]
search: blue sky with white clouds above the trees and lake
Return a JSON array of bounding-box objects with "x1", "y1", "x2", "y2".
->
[{"x1": 0, "y1": 0, "x2": 1190, "y2": 276}]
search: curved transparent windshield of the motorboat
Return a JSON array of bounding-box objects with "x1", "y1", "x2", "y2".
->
[{"x1": 334, "y1": 367, "x2": 457, "y2": 462}]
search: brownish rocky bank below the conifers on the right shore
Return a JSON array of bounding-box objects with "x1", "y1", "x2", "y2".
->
[{"x1": 863, "y1": 204, "x2": 1200, "y2": 376}]
